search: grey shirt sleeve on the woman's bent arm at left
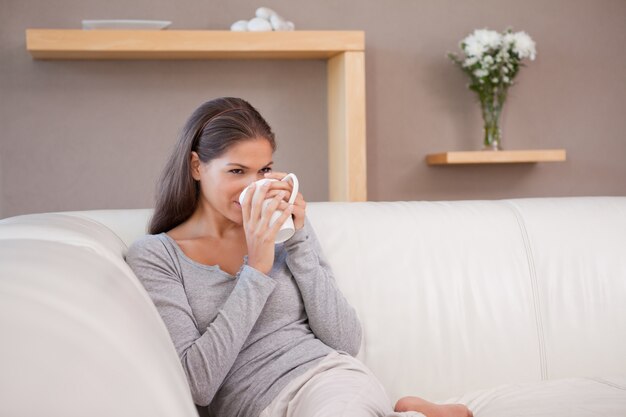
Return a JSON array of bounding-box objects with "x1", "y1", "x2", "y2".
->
[{"x1": 126, "y1": 236, "x2": 276, "y2": 406}]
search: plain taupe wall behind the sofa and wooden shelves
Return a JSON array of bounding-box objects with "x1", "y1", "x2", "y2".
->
[{"x1": 0, "y1": 0, "x2": 626, "y2": 217}]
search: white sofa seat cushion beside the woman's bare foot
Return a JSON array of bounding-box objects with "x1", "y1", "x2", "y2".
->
[{"x1": 446, "y1": 376, "x2": 626, "y2": 417}]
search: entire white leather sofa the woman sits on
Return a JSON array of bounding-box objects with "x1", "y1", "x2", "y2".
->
[{"x1": 0, "y1": 197, "x2": 626, "y2": 417}]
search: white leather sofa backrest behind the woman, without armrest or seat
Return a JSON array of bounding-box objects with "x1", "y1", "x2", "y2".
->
[{"x1": 0, "y1": 197, "x2": 626, "y2": 406}]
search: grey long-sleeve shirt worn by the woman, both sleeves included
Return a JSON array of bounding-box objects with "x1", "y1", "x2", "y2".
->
[{"x1": 126, "y1": 219, "x2": 361, "y2": 417}]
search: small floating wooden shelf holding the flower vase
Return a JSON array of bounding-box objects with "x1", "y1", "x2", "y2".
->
[{"x1": 426, "y1": 149, "x2": 566, "y2": 165}]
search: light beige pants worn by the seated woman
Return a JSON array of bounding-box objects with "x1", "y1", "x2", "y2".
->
[{"x1": 259, "y1": 352, "x2": 424, "y2": 417}]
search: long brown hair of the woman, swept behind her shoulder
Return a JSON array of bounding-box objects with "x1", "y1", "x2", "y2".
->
[{"x1": 148, "y1": 97, "x2": 276, "y2": 234}]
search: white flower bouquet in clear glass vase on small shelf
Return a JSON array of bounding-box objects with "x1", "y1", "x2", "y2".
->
[{"x1": 448, "y1": 29, "x2": 537, "y2": 150}]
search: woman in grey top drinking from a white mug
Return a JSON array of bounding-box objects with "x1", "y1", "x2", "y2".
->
[{"x1": 127, "y1": 98, "x2": 470, "y2": 417}]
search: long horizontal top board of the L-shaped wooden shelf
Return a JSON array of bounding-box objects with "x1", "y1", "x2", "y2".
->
[{"x1": 26, "y1": 29, "x2": 365, "y2": 59}]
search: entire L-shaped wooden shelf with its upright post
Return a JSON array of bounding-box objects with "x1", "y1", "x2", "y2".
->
[{"x1": 26, "y1": 29, "x2": 367, "y2": 201}]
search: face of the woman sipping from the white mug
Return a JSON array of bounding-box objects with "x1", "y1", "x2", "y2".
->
[{"x1": 192, "y1": 138, "x2": 273, "y2": 224}]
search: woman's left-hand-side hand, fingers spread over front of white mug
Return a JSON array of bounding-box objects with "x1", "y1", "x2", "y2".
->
[{"x1": 241, "y1": 181, "x2": 293, "y2": 275}]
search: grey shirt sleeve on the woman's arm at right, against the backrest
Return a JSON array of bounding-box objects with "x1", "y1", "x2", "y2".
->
[{"x1": 285, "y1": 218, "x2": 361, "y2": 356}]
